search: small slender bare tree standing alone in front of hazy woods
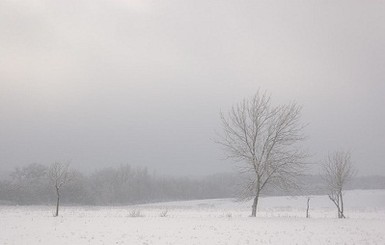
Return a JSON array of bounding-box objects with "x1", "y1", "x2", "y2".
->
[{"x1": 48, "y1": 162, "x2": 71, "y2": 217}]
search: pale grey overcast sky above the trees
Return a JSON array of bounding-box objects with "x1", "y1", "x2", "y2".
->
[{"x1": 0, "y1": 0, "x2": 385, "y2": 175}]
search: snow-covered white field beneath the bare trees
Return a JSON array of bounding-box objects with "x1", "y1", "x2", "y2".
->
[{"x1": 0, "y1": 190, "x2": 385, "y2": 245}]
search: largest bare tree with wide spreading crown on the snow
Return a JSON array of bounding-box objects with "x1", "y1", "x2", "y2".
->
[{"x1": 218, "y1": 92, "x2": 306, "y2": 217}]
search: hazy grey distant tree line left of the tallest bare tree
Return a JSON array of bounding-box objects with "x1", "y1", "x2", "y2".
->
[{"x1": 0, "y1": 163, "x2": 237, "y2": 205}]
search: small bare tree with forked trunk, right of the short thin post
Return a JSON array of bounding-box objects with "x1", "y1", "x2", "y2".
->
[{"x1": 323, "y1": 151, "x2": 355, "y2": 218}]
